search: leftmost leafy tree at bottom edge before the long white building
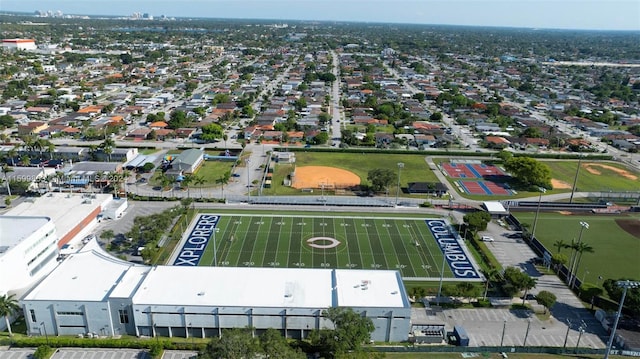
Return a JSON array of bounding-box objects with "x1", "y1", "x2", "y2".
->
[{"x1": 199, "y1": 328, "x2": 258, "y2": 359}]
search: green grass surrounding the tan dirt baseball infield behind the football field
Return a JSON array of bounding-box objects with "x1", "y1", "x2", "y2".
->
[{"x1": 262, "y1": 152, "x2": 437, "y2": 196}]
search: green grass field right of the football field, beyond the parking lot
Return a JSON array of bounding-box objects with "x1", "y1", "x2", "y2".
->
[{"x1": 515, "y1": 212, "x2": 640, "y2": 285}]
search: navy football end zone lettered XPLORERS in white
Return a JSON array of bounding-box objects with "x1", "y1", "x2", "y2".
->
[{"x1": 167, "y1": 213, "x2": 220, "y2": 267}]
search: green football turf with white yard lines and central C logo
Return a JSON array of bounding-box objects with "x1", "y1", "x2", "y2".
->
[{"x1": 185, "y1": 214, "x2": 478, "y2": 280}]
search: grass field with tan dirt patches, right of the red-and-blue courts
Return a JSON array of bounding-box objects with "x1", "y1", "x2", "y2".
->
[{"x1": 544, "y1": 161, "x2": 640, "y2": 192}]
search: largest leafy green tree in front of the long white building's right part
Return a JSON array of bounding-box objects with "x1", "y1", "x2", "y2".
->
[{"x1": 310, "y1": 307, "x2": 375, "y2": 355}]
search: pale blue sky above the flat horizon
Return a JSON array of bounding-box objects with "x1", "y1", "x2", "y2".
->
[{"x1": 0, "y1": 0, "x2": 640, "y2": 30}]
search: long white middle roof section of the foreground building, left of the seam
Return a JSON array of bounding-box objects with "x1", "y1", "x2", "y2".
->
[{"x1": 133, "y1": 266, "x2": 332, "y2": 308}]
